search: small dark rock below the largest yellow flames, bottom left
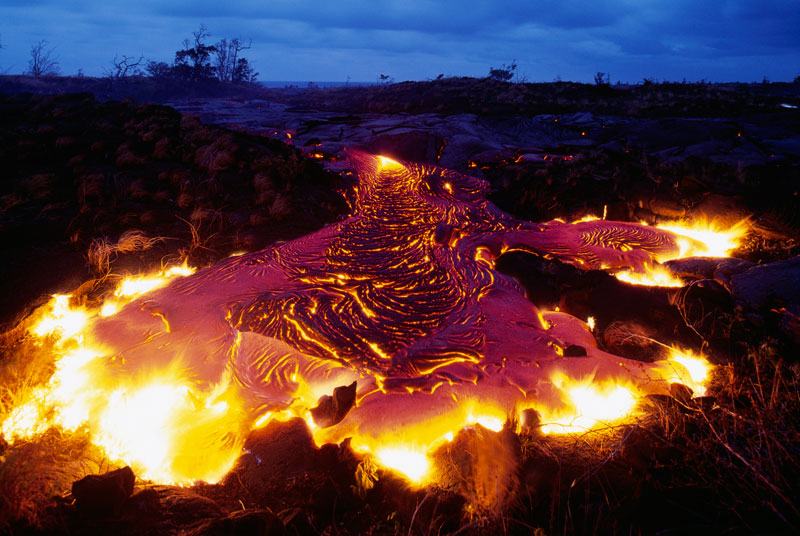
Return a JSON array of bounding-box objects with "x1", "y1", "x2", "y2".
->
[{"x1": 72, "y1": 466, "x2": 136, "y2": 514}]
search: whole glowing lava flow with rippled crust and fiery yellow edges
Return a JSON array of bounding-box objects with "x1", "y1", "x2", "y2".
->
[{"x1": 2, "y1": 153, "x2": 724, "y2": 483}]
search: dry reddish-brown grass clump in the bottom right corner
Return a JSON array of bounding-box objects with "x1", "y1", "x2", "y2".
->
[{"x1": 680, "y1": 343, "x2": 800, "y2": 530}]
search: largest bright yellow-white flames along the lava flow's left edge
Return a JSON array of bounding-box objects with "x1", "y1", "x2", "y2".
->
[{"x1": 0, "y1": 264, "x2": 233, "y2": 483}]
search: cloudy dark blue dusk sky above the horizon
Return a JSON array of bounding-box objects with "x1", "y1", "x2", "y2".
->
[{"x1": 0, "y1": 0, "x2": 800, "y2": 81}]
